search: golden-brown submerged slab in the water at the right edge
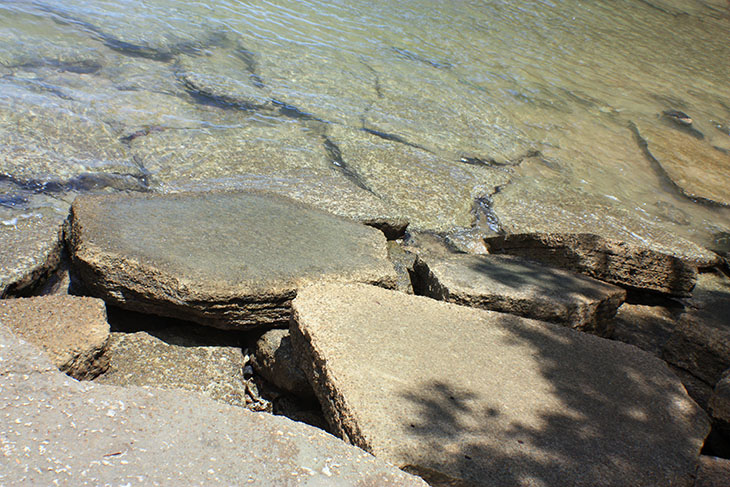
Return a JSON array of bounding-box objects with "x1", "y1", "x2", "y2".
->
[{"x1": 638, "y1": 124, "x2": 730, "y2": 206}]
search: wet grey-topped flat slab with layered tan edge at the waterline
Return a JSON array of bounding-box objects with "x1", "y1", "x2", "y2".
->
[{"x1": 70, "y1": 192, "x2": 396, "y2": 329}]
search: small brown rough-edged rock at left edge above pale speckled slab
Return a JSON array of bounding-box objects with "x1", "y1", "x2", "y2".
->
[{"x1": 0, "y1": 296, "x2": 109, "y2": 380}]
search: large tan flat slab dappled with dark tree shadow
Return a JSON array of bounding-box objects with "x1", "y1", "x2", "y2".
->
[{"x1": 291, "y1": 283, "x2": 708, "y2": 487}]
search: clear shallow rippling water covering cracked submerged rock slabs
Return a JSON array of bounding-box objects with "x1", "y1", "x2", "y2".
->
[{"x1": 0, "y1": 0, "x2": 730, "y2": 255}]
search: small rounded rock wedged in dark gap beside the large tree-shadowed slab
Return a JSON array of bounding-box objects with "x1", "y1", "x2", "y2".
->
[{"x1": 253, "y1": 329, "x2": 314, "y2": 397}]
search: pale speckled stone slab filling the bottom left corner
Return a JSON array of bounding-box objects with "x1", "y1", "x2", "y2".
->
[{"x1": 0, "y1": 327, "x2": 426, "y2": 487}]
